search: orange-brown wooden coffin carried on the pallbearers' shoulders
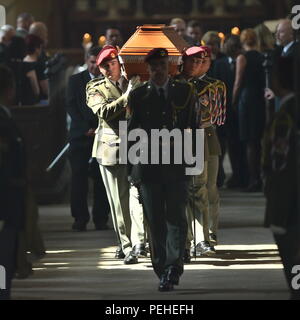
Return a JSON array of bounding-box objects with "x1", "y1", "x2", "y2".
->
[{"x1": 119, "y1": 24, "x2": 188, "y2": 81}]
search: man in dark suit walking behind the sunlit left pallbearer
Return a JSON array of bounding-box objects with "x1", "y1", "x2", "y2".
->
[{"x1": 67, "y1": 48, "x2": 109, "y2": 231}]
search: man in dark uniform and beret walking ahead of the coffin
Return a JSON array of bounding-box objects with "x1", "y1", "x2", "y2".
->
[{"x1": 129, "y1": 48, "x2": 195, "y2": 291}]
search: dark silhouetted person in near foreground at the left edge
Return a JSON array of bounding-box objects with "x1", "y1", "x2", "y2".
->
[{"x1": 0, "y1": 66, "x2": 26, "y2": 300}]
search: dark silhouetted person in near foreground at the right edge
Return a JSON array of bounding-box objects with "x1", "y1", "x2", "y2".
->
[{"x1": 262, "y1": 57, "x2": 300, "y2": 300}]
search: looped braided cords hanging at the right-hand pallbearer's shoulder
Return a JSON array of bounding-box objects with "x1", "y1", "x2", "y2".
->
[{"x1": 199, "y1": 79, "x2": 227, "y2": 126}]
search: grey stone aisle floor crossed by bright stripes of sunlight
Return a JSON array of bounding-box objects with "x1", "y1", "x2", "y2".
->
[{"x1": 12, "y1": 190, "x2": 289, "y2": 300}]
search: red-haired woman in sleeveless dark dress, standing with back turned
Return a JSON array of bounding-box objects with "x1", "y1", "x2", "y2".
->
[{"x1": 233, "y1": 29, "x2": 265, "y2": 192}]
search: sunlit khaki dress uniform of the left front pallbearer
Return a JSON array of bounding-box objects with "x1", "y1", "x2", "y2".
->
[{"x1": 87, "y1": 78, "x2": 144, "y2": 255}]
